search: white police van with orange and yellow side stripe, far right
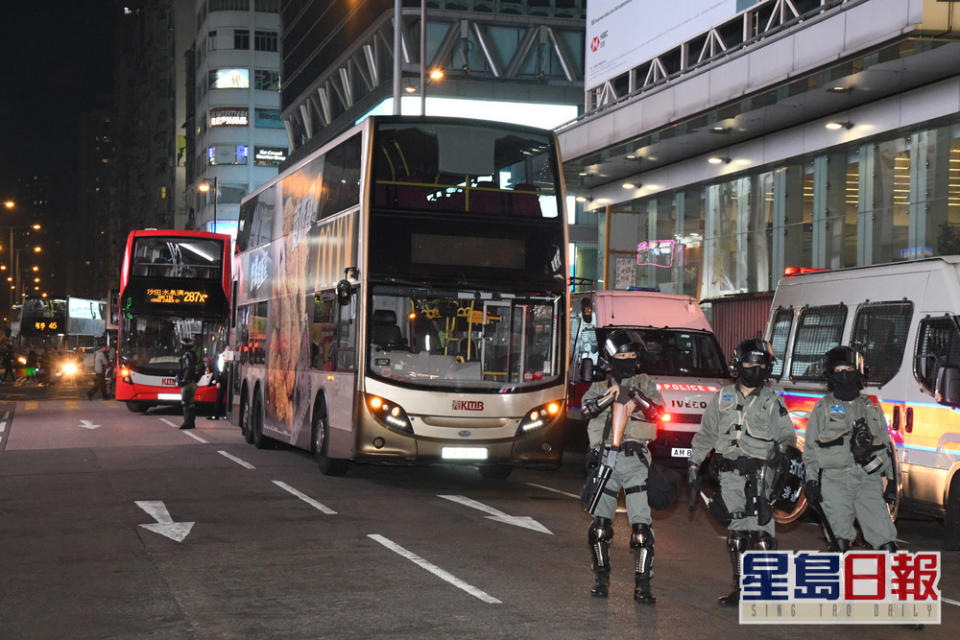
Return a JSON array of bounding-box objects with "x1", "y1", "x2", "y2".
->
[{"x1": 765, "y1": 256, "x2": 960, "y2": 549}]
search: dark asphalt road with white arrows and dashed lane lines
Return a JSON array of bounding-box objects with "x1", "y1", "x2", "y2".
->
[{"x1": 0, "y1": 387, "x2": 960, "y2": 640}]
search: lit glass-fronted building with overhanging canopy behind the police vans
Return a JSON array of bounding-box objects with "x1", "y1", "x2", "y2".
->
[{"x1": 560, "y1": 0, "x2": 960, "y2": 300}]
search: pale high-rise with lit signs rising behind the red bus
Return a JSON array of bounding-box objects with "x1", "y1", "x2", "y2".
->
[{"x1": 189, "y1": 0, "x2": 288, "y2": 233}]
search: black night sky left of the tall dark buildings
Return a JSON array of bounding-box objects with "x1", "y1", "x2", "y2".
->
[{"x1": 0, "y1": 0, "x2": 113, "y2": 208}]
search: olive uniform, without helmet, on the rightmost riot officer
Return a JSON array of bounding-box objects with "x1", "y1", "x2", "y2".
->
[{"x1": 803, "y1": 393, "x2": 897, "y2": 551}]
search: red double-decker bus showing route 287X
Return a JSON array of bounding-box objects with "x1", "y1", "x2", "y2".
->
[{"x1": 116, "y1": 229, "x2": 232, "y2": 411}]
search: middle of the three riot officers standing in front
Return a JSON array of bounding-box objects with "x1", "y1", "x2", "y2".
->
[{"x1": 687, "y1": 339, "x2": 796, "y2": 607}]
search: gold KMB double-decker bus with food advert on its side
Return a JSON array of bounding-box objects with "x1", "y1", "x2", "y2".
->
[{"x1": 235, "y1": 117, "x2": 568, "y2": 478}]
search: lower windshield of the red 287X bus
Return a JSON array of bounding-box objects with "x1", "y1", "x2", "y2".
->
[{"x1": 120, "y1": 315, "x2": 226, "y2": 376}]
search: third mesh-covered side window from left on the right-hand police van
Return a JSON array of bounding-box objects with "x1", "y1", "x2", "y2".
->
[{"x1": 850, "y1": 302, "x2": 913, "y2": 385}]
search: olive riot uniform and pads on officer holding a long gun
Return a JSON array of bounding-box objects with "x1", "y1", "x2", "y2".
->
[{"x1": 583, "y1": 330, "x2": 663, "y2": 604}]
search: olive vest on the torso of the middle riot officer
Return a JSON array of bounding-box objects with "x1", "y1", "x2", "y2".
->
[{"x1": 714, "y1": 384, "x2": 780, "y2": 460}]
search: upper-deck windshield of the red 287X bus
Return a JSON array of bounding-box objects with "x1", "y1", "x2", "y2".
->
[{"x1": 130, "y1": 236, "x2": 223, "y2": 280}]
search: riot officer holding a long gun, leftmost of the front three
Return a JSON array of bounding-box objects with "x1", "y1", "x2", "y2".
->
[{"x1": 583, "y1": 329, "x2": 663, "y2": 604}]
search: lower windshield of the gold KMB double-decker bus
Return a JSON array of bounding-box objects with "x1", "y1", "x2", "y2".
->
[{"x1": 367, "y1": 286, "x2": 563, "y2": 392}]
